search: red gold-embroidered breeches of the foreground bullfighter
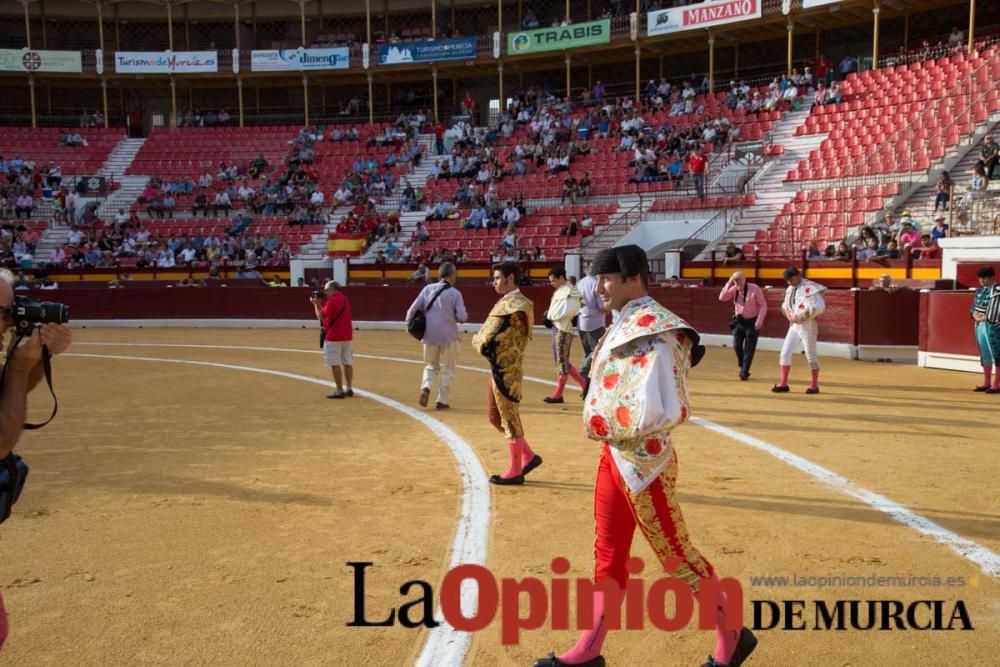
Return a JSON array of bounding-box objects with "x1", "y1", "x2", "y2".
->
[{"x1": 594, "y1": 444, "x2": 714, "y2": 592}]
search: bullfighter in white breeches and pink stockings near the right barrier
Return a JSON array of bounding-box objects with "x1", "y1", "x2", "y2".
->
[{"x1": 771, "y1": 266, "x2": 826, "y2": 394}]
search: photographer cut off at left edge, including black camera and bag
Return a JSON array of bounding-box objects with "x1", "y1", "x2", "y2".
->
[{"x1": 0, "y1": 269, "x2": 73, "y2": 648}]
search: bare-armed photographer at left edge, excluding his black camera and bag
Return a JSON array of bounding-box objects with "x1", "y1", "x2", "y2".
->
[{"x1": 0, "y1": 269, "x2": 73, "y2": 648}]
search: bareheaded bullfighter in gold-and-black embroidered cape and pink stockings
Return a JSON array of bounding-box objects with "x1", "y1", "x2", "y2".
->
[{"x1": 472, "y1": 262, "x2": 542, "y2": 486}]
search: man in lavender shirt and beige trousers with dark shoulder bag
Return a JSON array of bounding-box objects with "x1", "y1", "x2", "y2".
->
[{"x1": 406, "y1": 262, "x2": 469, "y2": 410}]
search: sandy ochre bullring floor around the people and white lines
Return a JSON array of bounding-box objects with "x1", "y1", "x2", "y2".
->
[{"x1": 0, "y1": 329, "x2": 1000, "y2": 667}]
